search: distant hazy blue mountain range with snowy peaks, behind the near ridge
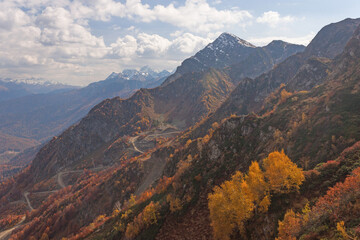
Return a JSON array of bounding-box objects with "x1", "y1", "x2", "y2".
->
[{"x1": 0, "y1": 67, "x2": 170, "y2": 165}]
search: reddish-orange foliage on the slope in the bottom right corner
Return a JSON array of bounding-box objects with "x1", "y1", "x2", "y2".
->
[{"x1": 278, "y1": 167, "x2": 360, "y2": 240}]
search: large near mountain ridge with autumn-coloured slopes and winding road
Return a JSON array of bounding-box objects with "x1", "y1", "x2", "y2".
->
[{"x1": 0, "y1": 19, "x2": 360, "y2": 239}]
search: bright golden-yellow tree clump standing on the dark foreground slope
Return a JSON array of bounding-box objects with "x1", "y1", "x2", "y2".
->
[{"x1": 208, "y1": 151, "x2": 304, "y2": 240}]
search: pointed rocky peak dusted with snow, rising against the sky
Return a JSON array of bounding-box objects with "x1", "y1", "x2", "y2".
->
[{"x1": 164, "y1": 33, "x2": 305, "y2": 84}]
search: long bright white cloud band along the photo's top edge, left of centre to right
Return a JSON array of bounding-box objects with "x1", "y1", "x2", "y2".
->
[{"x1": 69, "y1": 0, "x2": 252, "y2": 33}]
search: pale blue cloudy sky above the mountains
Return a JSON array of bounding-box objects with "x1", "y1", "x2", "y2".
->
[{"x1": 0, "y1": 0, "x2": 360, "y2": 86}]
